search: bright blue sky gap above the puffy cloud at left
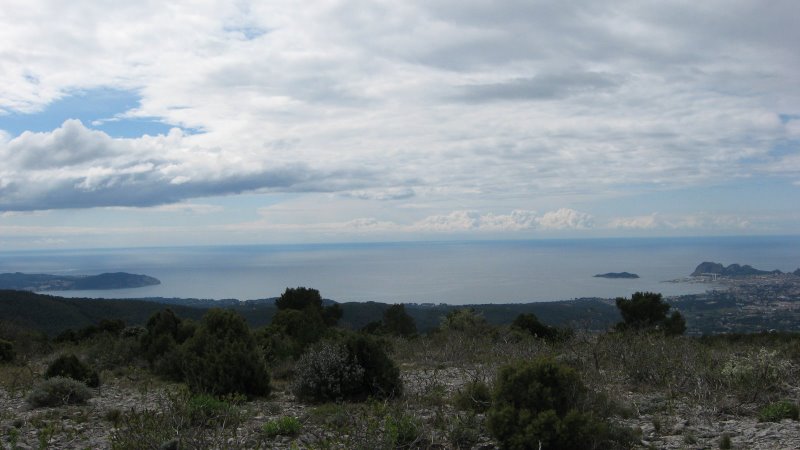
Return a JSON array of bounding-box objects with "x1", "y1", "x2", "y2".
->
[{"x1": 0, "y1": 89, "x2": 173, "y2": 138}]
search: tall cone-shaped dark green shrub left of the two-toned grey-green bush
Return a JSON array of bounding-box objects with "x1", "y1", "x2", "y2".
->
[{"x1": 182, "y1": 309, "x2": 270, "y2": 396}]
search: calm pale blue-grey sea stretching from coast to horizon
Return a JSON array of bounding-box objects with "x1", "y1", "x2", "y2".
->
[{"x1": 0, "y1": 236, "x2": 800, "y2": 304}]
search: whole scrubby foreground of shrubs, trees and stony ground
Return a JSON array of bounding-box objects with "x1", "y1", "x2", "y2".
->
[{"x1": 0, "y1": 288, "x2": 800, "y2": 449}]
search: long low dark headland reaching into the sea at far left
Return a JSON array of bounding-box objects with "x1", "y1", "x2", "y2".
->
[{"x1": 0, "y1": 272, "x2": 161, "y2": 292}]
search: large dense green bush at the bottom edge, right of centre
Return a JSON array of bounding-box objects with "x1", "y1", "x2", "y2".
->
[{"x1": 487, "y1": 358, "x2": 627, "y2": 450}]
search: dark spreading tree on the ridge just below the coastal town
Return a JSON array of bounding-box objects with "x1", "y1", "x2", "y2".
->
[{"x1": 616, "y1": 292, "x2": 686, "y2": 335}]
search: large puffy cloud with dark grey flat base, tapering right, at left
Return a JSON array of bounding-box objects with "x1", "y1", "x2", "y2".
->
[{"x1": 0, "y1": 120, "x2": 382, "y2": 211}]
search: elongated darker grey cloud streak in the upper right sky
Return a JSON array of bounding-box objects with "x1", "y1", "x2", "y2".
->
[{"x1": 457, "y1": 72, "x2": 619, "y2": 102}]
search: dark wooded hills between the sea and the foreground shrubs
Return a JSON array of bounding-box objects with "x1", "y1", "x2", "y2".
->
[{"x1": 0, "y1": 290, "x2": 620, "y2": 336}]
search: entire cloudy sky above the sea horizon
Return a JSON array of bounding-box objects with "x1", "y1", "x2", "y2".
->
[{"x1": 0, "y1": 0, "x2": 800, "y2": 250}]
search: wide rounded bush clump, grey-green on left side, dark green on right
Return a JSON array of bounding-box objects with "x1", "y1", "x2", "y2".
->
[{"x1": 292, "y1": 335, "x2": 402, "y2": 402}]
